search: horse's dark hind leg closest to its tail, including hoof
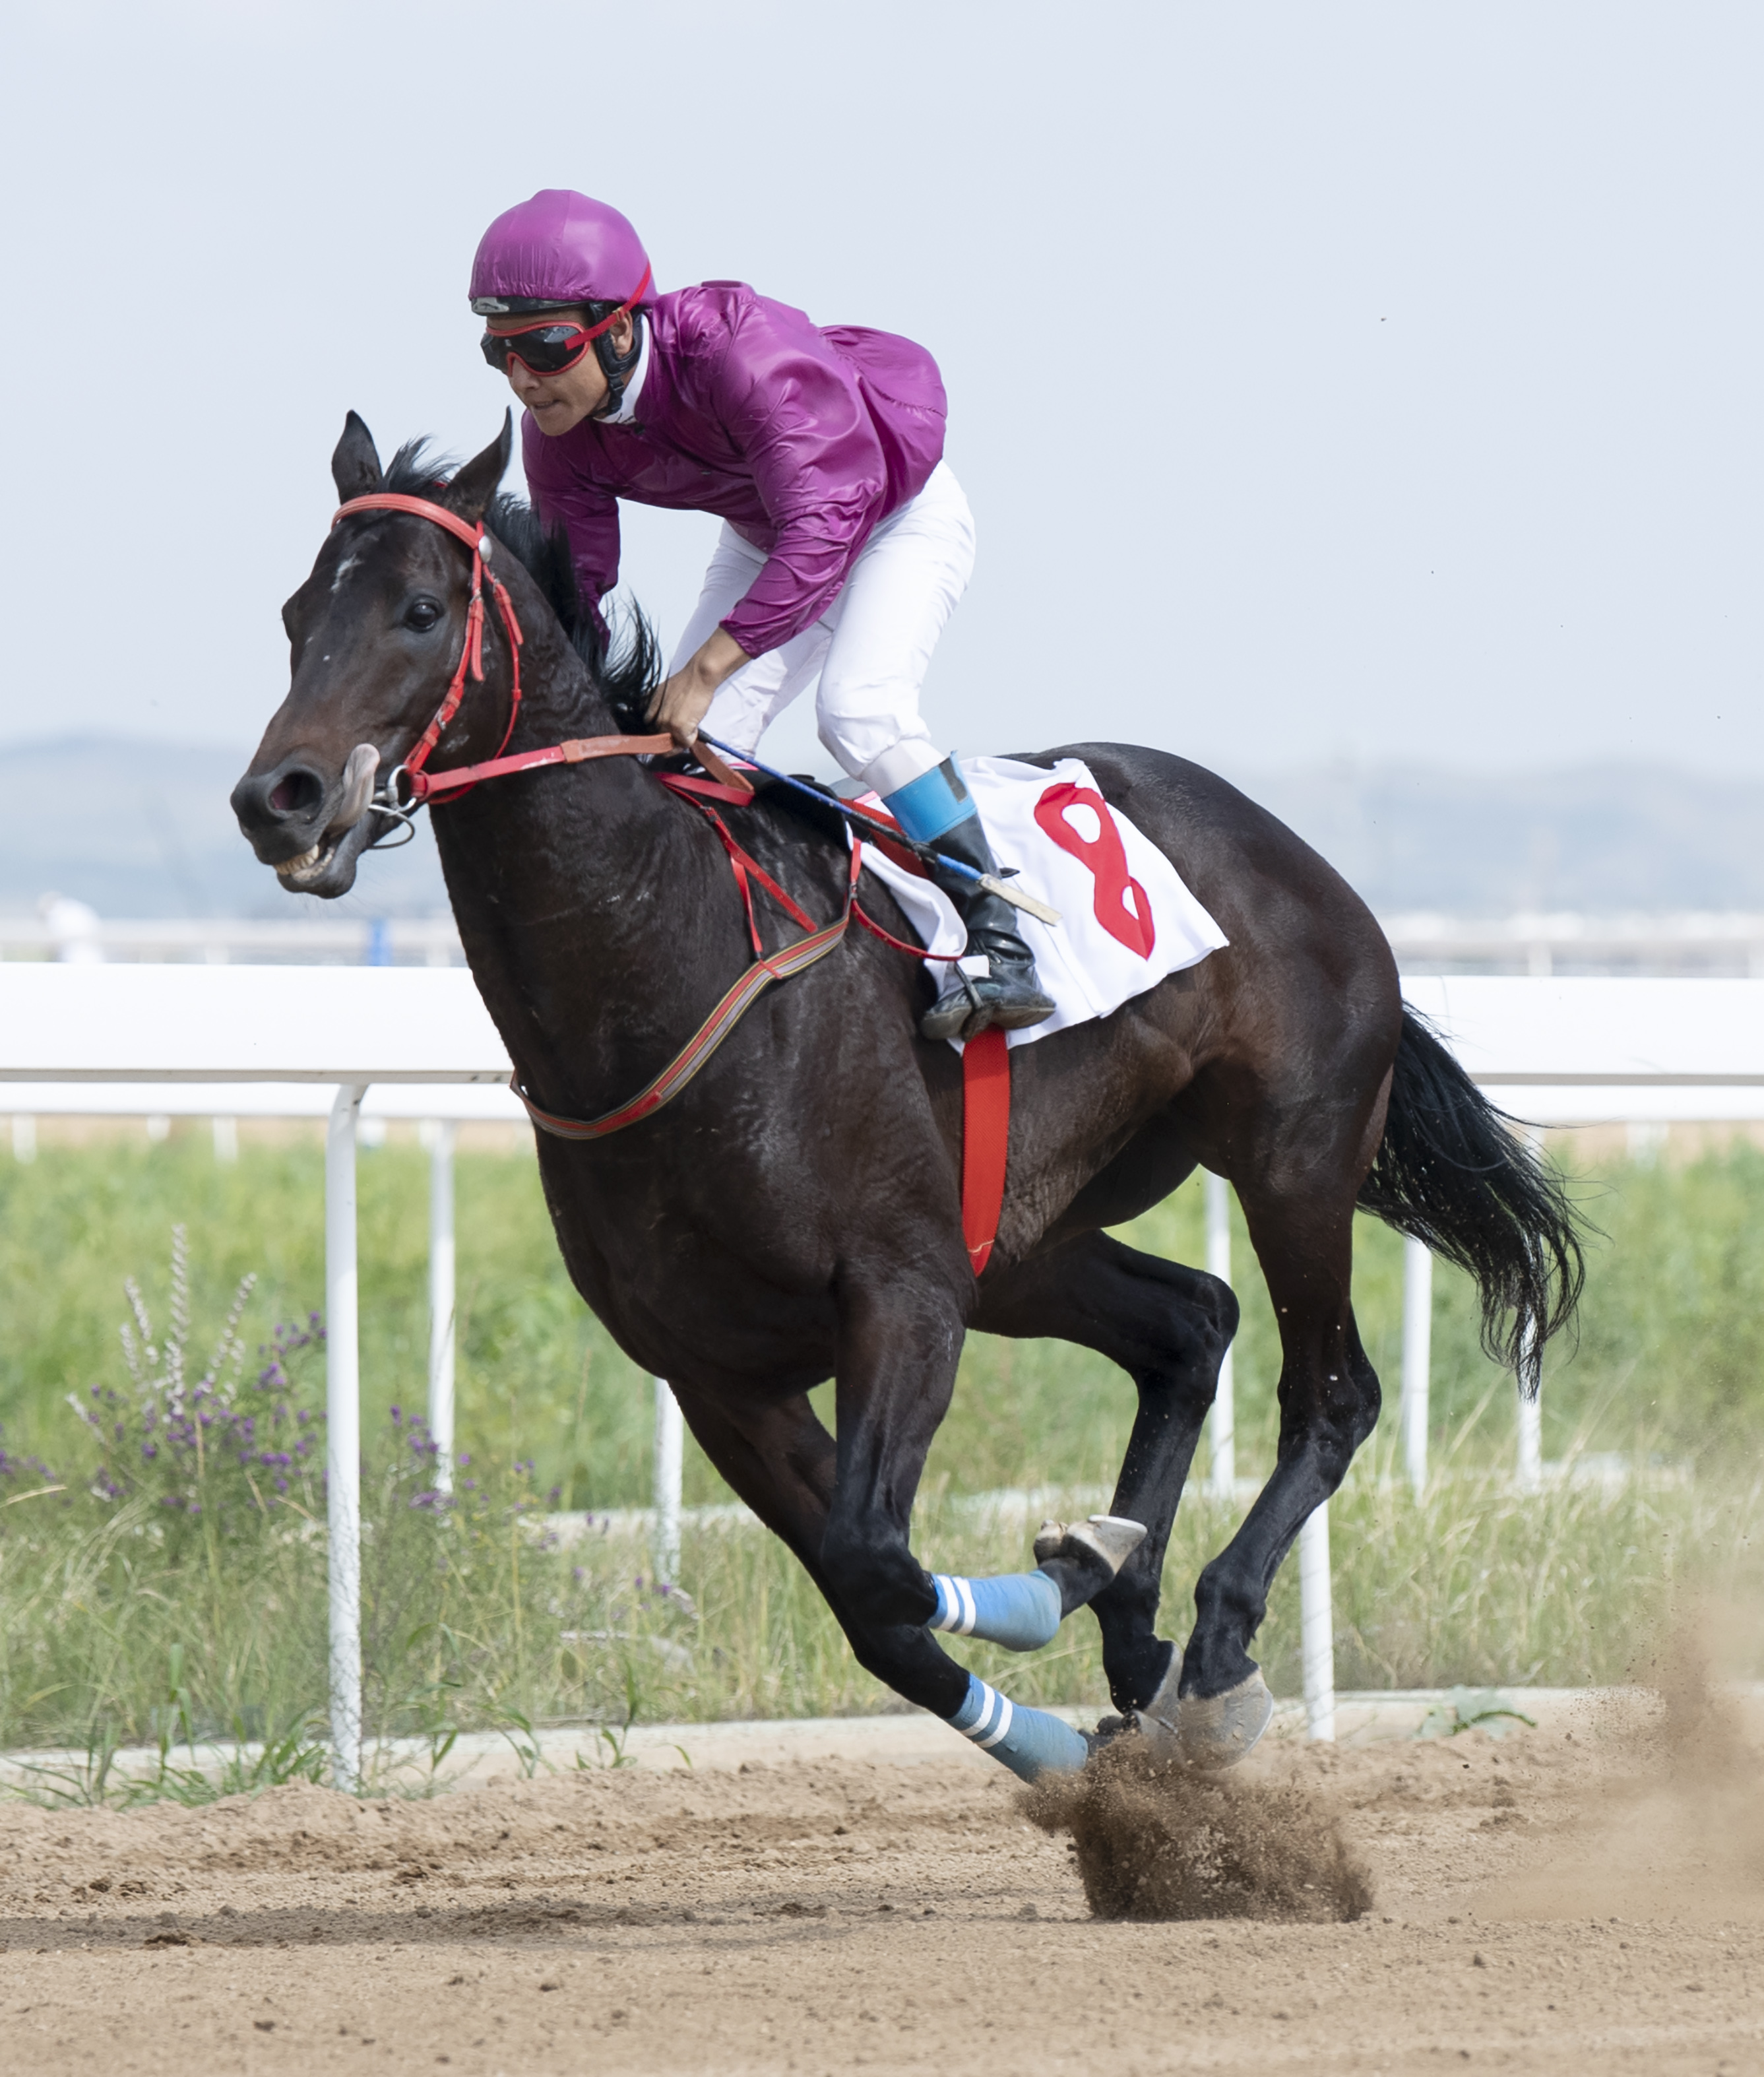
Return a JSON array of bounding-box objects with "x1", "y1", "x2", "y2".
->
[{"x1": 1159, "y1": 1186, "x2": 1379, "y2": 1766}]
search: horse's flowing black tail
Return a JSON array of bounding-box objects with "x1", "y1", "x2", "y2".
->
[{"x1": 1359, "y1": 1007, "x2": 1585, "y2": 1398}]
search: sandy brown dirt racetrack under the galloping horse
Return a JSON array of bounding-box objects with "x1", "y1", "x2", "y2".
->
[{"x1": 0, "y1": 1703, "x2": 1764, "y2": 2077}]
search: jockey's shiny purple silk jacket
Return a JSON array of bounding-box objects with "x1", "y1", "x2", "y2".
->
[{"x1": 522, "y1": 280, "x2": 947, "y2": 656}]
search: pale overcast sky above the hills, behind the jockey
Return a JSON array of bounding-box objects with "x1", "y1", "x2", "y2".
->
[{"x1": 0, "y1": 0, "x2": 1764, "y2": 775}]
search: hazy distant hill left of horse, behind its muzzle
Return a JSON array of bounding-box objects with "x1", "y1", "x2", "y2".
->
[{"x1": 0, "y1": 735, "x2": 447, "y2": 916}]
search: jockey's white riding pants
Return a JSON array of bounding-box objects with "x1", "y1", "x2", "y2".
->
[{"x1": 667, "y1": 461, "x2": 974, "y2": 794}]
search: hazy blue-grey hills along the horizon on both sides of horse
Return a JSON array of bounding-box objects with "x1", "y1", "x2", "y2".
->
[{"x1": 0, "y1": 738, "x2": 1764, "y2": 916}]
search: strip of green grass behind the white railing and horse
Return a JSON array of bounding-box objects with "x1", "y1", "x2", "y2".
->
[{"x1": 0, "y1": 1134, "x2": 1764, "y2": 1772}]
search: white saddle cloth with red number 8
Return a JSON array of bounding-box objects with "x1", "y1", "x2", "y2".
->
[{"x1": 858, "y1": 758, "x2": 1230, "y2": 1051}]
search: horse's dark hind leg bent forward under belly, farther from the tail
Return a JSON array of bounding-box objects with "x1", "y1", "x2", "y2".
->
[{"x1": 974, "y1": 1234, "x2": 1236, "y2": 1710}]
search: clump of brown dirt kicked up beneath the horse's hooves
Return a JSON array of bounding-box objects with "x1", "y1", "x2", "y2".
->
[{"x1": 1009, "y1": 1739, "x2": 1371, "y2": 1923}]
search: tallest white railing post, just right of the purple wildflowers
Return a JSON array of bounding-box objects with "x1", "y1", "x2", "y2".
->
[{"x1": 324, "y1": 1082, "x2": 367, "y2": 1795}]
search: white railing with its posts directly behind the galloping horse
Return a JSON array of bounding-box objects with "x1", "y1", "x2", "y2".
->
[{"x1": 0, "y1": 962, "x2": 1764, "y2": 1761}]
